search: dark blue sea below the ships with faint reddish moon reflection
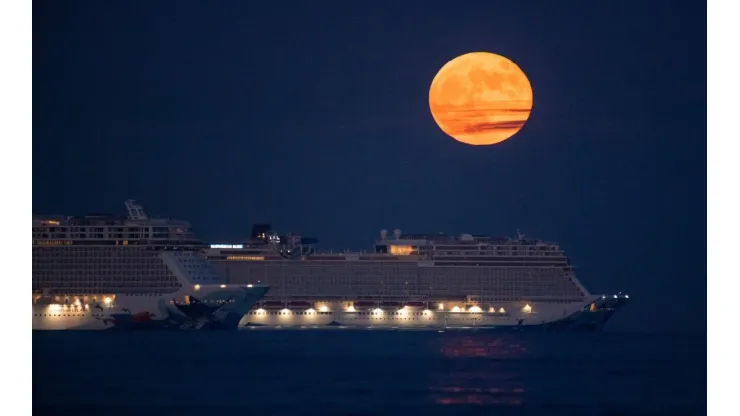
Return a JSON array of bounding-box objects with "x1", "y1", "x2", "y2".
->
[{"x1": 33, "y1": 330, "x2": 707, "y2": 416}]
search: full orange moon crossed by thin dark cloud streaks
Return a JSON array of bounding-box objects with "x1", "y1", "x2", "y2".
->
[{"x1": 429, "y1": 52, "x2": 532, "y2": 146}]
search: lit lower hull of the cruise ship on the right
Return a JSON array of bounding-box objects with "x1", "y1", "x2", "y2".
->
[{"x1": 241, "y1": 295, "x2": 627, "y2": 331}]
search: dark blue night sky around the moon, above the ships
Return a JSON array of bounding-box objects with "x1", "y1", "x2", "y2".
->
[{"x1": 33, "y1": 0, "x2": 706, "y2": 330}]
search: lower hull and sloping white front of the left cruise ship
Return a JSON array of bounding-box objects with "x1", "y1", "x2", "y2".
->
[{"x1": 32, "y1": 251, "x2": 269, "y2": 330}]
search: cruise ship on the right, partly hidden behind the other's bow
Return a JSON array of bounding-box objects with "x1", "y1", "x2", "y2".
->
[{"x1": 206, "y1": 224, "x2": 629, "y2": 331}]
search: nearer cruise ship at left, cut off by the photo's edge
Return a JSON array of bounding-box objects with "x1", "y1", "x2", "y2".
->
[{"x1": 32, "y1": 200, "x2": 269, "y2": 330}]
